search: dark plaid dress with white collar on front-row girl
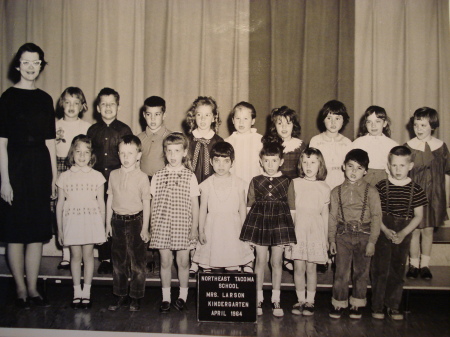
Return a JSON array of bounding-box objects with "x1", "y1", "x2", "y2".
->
[{"x1": 240, "y1": 175, "x2": 297, "y2": 246}]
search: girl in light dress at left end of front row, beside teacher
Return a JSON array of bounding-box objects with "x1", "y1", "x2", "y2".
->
[{"x1": 56, "y1": 135, "x2": 106, "y2": 309}]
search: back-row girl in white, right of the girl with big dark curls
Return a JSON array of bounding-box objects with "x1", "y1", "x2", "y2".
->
[{"x1": 309, "y1": 100, "x2": 352, "y2": 189}]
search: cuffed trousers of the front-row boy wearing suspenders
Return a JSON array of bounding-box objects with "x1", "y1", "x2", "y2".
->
[{"x1": 331, "y1": 231, "x2": 370, "y2": 308}]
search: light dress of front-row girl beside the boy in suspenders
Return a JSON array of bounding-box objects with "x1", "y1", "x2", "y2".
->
[{"x1": 287, "y1": 178, "x2": 330, "y2": 263}]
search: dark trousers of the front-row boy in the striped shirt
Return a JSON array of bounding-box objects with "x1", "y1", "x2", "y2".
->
[{"x1": 370, "y1": 213, "x2": 411, "y2": 311}]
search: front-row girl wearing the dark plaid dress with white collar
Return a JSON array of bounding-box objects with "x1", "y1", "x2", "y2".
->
[{"x1": 240, "y1": 143, "x2": 297, "y2": 317}]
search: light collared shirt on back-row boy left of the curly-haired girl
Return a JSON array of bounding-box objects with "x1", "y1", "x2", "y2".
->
[{"x1": 138, "y1": 125, "x2": 172, "y2": 176}]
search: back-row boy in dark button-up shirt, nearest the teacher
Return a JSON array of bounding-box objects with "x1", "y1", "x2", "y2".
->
[{"x1": 87, "y1": 88, "x2": 133, "y2": 274}]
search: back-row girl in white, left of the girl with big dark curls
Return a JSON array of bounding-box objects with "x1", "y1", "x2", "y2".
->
[{"x1": 225, "y1": 102, "x2": 262, "y2": 186}]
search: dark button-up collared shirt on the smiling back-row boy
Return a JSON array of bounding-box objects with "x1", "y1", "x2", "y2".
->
[{"x1": 87, "y1": 119, "x2": 133, "y2": 179}]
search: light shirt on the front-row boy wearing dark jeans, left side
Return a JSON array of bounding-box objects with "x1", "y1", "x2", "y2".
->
[{"x1": 107, "y1": 168, "x2": 151, "y2": 215}]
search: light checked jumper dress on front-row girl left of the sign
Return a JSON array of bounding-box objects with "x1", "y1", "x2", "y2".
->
[{"x1": 149, "y1": 167, "x2": 193, "y2": 250}]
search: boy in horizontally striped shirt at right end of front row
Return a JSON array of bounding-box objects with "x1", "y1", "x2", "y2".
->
[{"x1": 370, "y1": 146, "x2": 428, "y2": 320}]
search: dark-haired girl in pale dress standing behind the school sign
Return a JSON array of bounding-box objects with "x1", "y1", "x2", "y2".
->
[{"x1": 193, "y1": 142, "x2": 254, "y2": 272}]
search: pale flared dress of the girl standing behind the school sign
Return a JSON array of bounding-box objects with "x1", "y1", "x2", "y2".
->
[{"x1": 193, "y1": 175, "x2": 254, "y2": 267}]
